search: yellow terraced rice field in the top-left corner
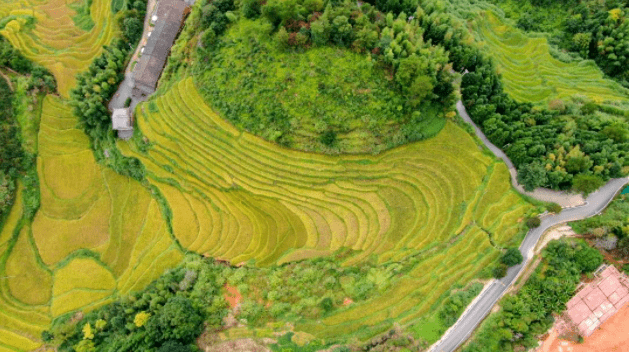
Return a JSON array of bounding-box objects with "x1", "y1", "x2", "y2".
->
[{"x1": 0, "y1": 0, "x2": 116, "y2": 97}]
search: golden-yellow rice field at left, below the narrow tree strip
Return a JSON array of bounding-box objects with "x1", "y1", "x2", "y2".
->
[{"x1": 0, "y1": 96, "x2": 182, "y2": 351}]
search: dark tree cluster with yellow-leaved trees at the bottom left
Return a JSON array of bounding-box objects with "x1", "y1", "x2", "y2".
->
[{"x1": 42, "y1": 256, "x2": 227, "y2": 352}]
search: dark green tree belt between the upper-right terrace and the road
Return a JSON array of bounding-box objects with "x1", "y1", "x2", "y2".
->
[{"x1": 402, "y1": 0, "x2": 628, "y2": 190}]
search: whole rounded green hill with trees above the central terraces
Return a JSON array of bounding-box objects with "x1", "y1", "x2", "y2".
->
[{"x1": 192, "y1": 1, "x2": 455, "y2": 153}]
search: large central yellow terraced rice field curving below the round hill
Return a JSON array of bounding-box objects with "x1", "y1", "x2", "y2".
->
[{"x1": 119, "y1": 78, "x2": 531, "y2": 337}]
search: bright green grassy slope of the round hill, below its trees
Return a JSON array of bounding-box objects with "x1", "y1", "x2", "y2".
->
[{"x1": 196, "y1": 20, "x2": 445, "y2": 153}]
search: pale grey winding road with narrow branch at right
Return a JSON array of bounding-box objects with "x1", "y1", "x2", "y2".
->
[{"x1": 430, "y1": 101, "x2": 628, "y2": 352}]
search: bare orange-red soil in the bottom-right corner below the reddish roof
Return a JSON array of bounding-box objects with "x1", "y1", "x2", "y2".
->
[{"x1": 542, "y1": 304, "x2": 630, "y2": 352}]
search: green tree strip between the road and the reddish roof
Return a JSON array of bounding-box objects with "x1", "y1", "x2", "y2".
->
[{"x1": 463, "y1": 240, "x2": 602, "y2": 352}]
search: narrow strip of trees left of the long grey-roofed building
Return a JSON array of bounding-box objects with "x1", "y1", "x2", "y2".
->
[{"x1": 70, "y1": 5, "x2": 146, "y2": 180}]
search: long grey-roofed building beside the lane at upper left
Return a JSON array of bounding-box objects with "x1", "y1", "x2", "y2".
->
[{"x1": 132, "y1": 0, "x2": 188, "y2": 99}]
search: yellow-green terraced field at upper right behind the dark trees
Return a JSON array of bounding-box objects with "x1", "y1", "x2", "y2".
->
[{"x1": 476, "y1": 11, "x2": 628, "y2": 103}]
